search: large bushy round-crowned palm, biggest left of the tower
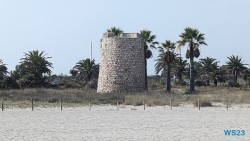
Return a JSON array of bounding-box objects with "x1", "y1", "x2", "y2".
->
[{"x1": 19, "y1": 50, "x2": 53, "y2": 87}]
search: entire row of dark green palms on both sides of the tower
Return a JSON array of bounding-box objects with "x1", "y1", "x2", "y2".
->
[{"x1": 0, "y1": 27, "x2": 250, "y2": 93}]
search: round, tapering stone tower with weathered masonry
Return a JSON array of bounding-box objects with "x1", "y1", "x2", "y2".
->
[{"x1": 97, "y1": 32, "x2": 146, "y2": 93}]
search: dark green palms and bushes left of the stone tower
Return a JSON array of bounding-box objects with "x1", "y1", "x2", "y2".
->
[{"x1": 0, "y1": 50, "x2": 99, "y2": 89}]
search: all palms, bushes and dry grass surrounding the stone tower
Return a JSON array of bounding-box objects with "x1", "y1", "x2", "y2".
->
[{"x1": 0, "y1": 27, "x2": 250, "y2": 107}]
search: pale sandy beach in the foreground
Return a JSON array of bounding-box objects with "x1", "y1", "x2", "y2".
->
[{"x1": 0, "y1": 106, "x2": 250, "y2": 141}]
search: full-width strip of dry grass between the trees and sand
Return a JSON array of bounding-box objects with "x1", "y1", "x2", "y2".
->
[{"x1": 0, "y1": 86, "x2": 250, "y2": 108}]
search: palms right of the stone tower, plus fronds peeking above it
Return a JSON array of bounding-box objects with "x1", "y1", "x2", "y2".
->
[{"x1": 103, "y1": 27, "x2": 250, "y2": 94}]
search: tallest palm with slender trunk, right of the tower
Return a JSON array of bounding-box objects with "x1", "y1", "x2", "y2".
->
[{"x1": 177, "y1": 27, "x2": 207, "y2": 93}]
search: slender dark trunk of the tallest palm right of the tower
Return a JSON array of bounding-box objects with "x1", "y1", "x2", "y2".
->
[{"x1": 190, "y1": 44, "x2": 195, "y2": 94}]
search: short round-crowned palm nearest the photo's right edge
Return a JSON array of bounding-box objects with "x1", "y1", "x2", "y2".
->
[{"x1": 226, "y1": 55, "x2": 248, "y2": 83}]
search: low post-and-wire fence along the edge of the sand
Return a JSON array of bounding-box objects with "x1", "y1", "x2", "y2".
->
[{"x1": 1, "y1": 98, "x2": 247, "y2": 111}]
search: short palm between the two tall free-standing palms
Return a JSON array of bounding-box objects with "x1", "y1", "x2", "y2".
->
[{"x1": 173, "y1": 57, "x2": 187, "y2": 83}]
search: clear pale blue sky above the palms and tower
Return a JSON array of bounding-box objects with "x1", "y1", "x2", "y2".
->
[{"x1": 0, "y1": 0, "x2": 250, "y2": 75}]
